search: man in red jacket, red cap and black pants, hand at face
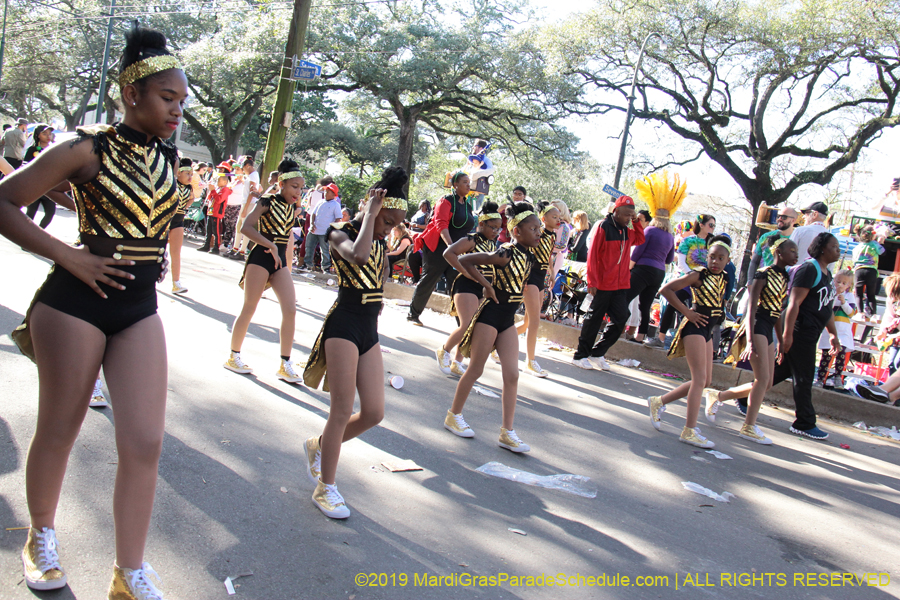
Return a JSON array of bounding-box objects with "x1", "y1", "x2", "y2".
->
[{"x1": 572, "y1": 196, "x2": 644, "y2": 371}]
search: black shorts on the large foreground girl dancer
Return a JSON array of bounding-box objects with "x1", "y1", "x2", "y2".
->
[{"x1": 35, "y1": 263, "x2": 162, "y2": 336}]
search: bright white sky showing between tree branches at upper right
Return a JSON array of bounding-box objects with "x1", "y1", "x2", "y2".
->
[{"x1": 532, "y1": 0, "x2": 900, "y2": 214}]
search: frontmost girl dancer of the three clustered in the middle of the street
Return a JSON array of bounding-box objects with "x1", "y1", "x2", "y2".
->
[{"x1": 444, "y1": 202, "x2": 540, "y2": 452}]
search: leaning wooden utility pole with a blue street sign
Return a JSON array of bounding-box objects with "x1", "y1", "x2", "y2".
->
[{"x1": 259, "y1": 0, "x2": 312, "y2": 181}]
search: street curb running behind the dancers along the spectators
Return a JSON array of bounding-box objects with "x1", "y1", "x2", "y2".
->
[{"x1": 294, "y1": 273, "x2": 900, "y2": 428}]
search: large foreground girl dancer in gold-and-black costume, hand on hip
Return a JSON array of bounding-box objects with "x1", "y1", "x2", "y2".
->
[{"x1": 0, "y1": 24, "x2": 188, "y2": 600}]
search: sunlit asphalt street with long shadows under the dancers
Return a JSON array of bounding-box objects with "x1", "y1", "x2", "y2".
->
[{"x1": 0, "y1": 211, "x2": 900, "y2": 600}]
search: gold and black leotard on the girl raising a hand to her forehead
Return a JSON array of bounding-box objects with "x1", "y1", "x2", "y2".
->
[{"x1": 303, "y1": 221, "x2": 387, "y2": 392}]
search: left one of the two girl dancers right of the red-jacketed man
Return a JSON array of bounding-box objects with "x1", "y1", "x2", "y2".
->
[{"x1": 647, "y1": 236, "x2": 731, "y2": 448}]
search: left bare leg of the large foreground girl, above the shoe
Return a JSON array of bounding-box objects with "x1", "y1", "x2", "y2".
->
[{"x1": 25, "y1": 303, "x2": 106, "y2": 529}]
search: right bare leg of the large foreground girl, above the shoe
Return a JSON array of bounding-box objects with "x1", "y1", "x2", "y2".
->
[{"x1": 103, "y1": 315, "x2": 168, "y2": 569}]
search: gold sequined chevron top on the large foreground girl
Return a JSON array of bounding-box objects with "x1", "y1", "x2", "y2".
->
[{"x1": 72, "y1": 125, "x2": 178, "y2": 239}]
